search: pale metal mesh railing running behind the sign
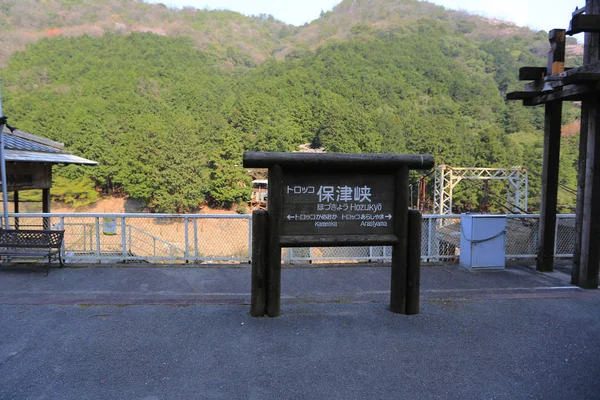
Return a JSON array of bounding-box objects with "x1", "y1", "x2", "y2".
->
[{"x1": 1, "y1": 213, "x2": 575, "y2": 264}]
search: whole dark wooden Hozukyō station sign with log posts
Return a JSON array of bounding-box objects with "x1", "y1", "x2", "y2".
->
[{"x1": 244, "y1": 153, "x2": 433, "y2": 317}]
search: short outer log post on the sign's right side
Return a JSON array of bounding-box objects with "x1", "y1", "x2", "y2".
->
[{"x1": 406, "y1": 210, "x2": 423, "y2": 315}]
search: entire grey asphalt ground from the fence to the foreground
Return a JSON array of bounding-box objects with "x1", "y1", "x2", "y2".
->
[{"x1": 0, "y1": 264, "x2": 600, "y2": 399}]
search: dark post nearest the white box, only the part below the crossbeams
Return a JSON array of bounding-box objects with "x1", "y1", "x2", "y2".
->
[{"x1": 536, "y1": 102, "x2": 562, "y2": 272}]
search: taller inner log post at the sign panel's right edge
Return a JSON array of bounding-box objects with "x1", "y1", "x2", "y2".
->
[{"x1": 390, "y1": 167, "x2": 408, "y2": 314}]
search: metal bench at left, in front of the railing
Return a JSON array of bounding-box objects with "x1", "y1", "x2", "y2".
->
[{"x1": 0, "y1": 229, "x2": 65, "y2": 267}]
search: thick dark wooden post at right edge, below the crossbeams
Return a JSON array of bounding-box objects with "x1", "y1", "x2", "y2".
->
[{"x1": 578, "y1": 99, "x2": 600, "y2": 289}]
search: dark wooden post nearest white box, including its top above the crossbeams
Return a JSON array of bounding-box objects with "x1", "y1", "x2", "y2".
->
[{"x1": 536, "y1": 29, "x2": 565, "y2": 272}]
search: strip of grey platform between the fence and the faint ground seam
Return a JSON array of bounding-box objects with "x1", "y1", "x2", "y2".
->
[{"x1": 0, "y1": 263, "x2": 595, "y2": 305}]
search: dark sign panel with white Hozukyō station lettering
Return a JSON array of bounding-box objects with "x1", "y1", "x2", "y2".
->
[{"x1": 281, "y1": 172, "x2": 394, "y2": 236}]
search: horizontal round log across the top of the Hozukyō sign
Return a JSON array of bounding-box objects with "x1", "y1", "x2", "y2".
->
[{"x1": 243, "y1": 152, "x2": 434, "y2": 170}]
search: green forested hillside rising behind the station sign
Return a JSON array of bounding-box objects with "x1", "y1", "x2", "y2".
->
[{"x1": 0, "y1": 0, "x2": 579, "y2": 212}]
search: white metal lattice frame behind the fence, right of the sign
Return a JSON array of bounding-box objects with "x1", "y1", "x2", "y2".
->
[{"x1": 433, "y1": 165, "x2": 528, "y2": 215}]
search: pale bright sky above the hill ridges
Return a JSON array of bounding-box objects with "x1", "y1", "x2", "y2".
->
[{"x1": 146, "y1": 0, "x2": 585, "y2": 31}]
